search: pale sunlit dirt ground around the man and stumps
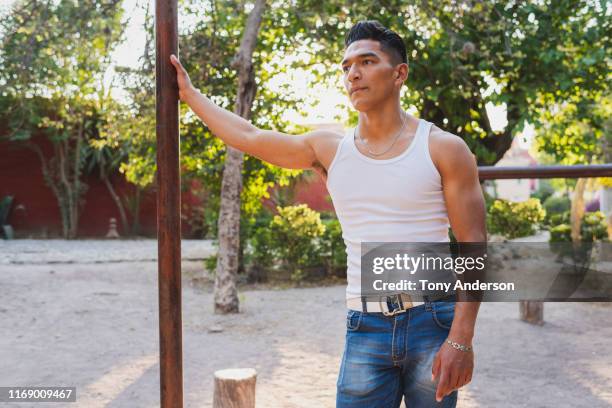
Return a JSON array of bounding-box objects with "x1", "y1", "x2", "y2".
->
[{"x1": 0, "y1": 241, "x2": 612, "y2": 408}]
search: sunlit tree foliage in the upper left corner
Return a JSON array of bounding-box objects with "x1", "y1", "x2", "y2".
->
[{"x1": 0, "y1": 0, "x2": 123, "y2": 98}]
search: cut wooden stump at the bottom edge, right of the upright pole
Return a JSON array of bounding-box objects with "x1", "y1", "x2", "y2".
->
[{"x1": 213, "y1": 368, "x2": 257, "y2": 408}]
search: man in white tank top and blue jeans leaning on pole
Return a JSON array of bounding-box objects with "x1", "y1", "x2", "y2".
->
[{"x1": 171, "y1": 21, "x2": 486, "y2": 408}]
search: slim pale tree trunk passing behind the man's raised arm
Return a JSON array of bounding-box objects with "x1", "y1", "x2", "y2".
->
[{"x1": 214, "y1": 0, "x2": 265, "y2": 313}]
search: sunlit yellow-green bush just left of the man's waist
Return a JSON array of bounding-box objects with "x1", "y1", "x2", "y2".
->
[{"x1": 270, "y1": 204, "x2": 325, "y2": 281}]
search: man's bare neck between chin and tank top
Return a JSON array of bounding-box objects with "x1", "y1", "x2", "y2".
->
[{"x1": 357, "y1": 104, "x2": 418, "y2": 143}]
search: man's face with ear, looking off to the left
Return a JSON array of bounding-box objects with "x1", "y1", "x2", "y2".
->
[{"x1": 341, "y1": 40, "x2": 408, "y2": 111}]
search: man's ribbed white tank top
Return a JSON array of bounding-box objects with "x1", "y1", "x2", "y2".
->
[{"x1": 327, "y1": 119, "x2": 449, "y2": 299}]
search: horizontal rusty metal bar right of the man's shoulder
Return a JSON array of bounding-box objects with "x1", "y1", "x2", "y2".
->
[{"x1": 478, "y1": 164, "x2": 612, "y2": 180}]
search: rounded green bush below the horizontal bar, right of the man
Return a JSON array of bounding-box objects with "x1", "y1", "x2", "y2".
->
[{"x1": 487, "y1": 198, "x2": 546, "y2": 239}]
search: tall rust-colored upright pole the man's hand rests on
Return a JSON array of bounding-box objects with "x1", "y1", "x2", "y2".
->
[{"x1": 155, "y1": 0, "x2": 183, "y2": 408}]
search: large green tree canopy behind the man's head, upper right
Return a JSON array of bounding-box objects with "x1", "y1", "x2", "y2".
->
[{"x1": 288, "y1": 0, "x2": 610, "y2": 164}]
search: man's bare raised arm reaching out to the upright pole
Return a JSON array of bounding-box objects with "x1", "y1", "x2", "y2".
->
[{"x1": 170, "y1": 55, "x2": 326, "y2": 169}]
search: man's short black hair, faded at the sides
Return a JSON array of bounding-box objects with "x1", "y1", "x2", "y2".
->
[{"x1": 344, "y1": 20, "x2": 408, "y2": 65}]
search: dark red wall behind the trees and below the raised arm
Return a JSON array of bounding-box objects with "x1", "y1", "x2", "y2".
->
[{"x1": 0, "y1": 132, "x2": 333, "y2": 238}]
